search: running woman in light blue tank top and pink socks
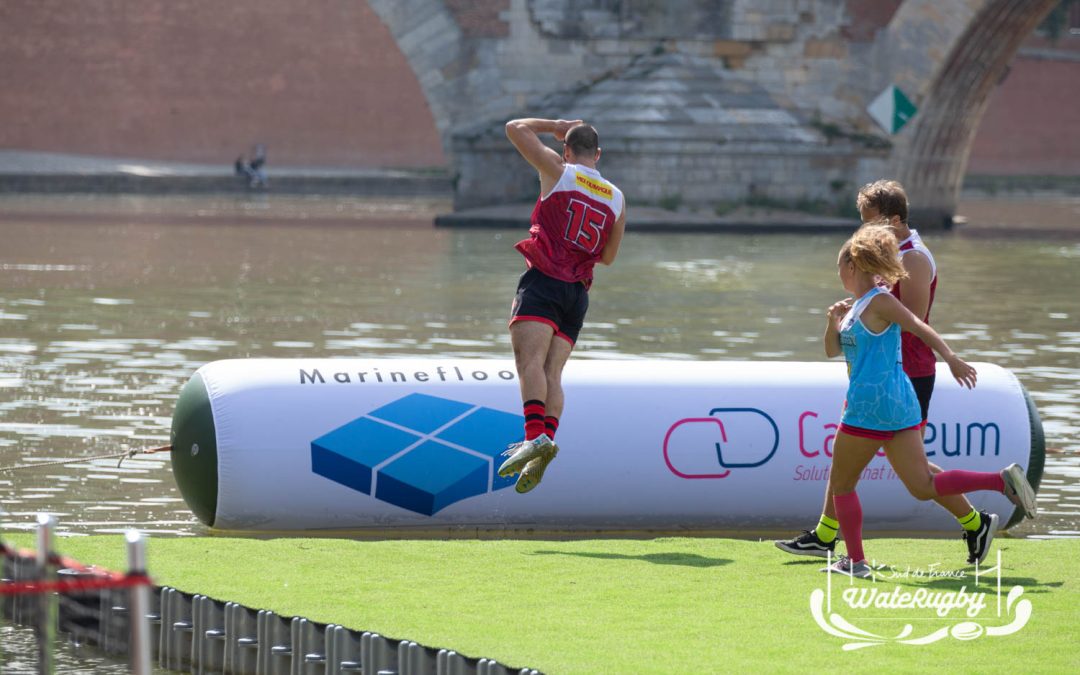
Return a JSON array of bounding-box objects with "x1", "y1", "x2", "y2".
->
[{"x1": 824, "y1": 225, "x2": 1036, "y2": 578}]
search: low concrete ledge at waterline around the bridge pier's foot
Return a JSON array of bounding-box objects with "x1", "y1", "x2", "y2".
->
[{"x1": 435, "y1": 204, "x2": 859, "y2": 234}]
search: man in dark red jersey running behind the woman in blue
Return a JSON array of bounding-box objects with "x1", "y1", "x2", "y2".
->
[{"x1": 775, "y1": 180, "x2": 998, "y2": 564}]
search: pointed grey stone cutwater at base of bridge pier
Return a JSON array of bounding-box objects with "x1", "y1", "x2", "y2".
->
[{"x1": 453, "y1": 54, "x2": 888, "y2": 210}]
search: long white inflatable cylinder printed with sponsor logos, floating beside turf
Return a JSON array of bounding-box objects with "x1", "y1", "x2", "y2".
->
[{"x1": 173, "y1": 359, "x2": 1043, "y2": 531}]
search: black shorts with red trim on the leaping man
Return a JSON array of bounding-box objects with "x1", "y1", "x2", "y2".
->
[{"x1": 510, "y1": 268, "x2": 589, "y2": 346}]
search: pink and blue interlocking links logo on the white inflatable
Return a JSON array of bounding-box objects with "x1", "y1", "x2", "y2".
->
[{"x1": 663, "y1": 408, "x2": 780, "y2": 480}]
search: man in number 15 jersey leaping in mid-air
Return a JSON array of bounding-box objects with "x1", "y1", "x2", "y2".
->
[{"x1": 499, "y1": 119, "x2": 626, "y2": 492}]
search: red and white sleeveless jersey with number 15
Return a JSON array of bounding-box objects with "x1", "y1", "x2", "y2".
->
[{"x1": 514, "y1": 164, "x2": 623, "y2": 288}]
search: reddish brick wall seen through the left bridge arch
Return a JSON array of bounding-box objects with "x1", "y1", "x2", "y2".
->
[{"x1": 0, "y1": 0, "x2": 446, "y2": 166}]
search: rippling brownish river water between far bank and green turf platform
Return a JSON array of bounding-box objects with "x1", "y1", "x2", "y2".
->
[{"x1": 0, "y1": 206, "x2": 1080, "y2": 537}]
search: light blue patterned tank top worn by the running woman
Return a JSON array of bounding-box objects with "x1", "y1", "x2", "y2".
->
[{"x1": 840, "y1": 286, "x2": 922, "y2": 431}]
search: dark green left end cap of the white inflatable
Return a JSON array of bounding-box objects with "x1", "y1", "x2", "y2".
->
[{"x1": 172, "y1": 373, "x2": 217, "y2": 526}]
